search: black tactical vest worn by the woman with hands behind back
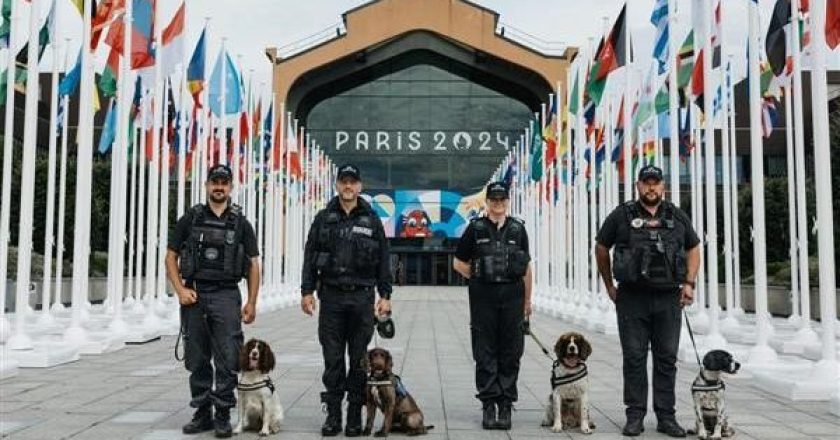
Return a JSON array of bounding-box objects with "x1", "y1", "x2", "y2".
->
[{"x1": 472, "y1": 217, "x2": 530, "y2": 283}]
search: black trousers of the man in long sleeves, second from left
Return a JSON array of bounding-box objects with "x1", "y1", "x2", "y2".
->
[{"x1": 318, "y1": 284, "x2": 375, "y2": 405}]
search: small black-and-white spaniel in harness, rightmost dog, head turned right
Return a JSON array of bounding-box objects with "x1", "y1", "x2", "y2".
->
[{"x1": 689, "y1": 350, "x2": 741, "y2": 440}]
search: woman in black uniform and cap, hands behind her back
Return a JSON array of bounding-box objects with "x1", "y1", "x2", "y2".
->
[{"x1": 453, "y1": 182, "x2": 531, "y2": 430}]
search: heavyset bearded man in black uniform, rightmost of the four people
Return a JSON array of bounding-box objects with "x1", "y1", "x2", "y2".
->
[{"x1": 595, "y1": 165, "x2": 700, "y2": 437}]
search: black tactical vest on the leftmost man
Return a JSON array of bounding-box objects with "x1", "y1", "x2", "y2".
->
[{"x1": 180, "y1": 204, "x2": 249, "y2": 282}]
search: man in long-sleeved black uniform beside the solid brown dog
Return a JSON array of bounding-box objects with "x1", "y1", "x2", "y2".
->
[{"x1": 300, "y1": 164, "x2": 391, "y2": 437}]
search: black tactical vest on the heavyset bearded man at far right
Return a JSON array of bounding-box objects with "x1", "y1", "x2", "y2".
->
[{"x1": 613, "y1": 201, "x2": 687, "y2": 290}]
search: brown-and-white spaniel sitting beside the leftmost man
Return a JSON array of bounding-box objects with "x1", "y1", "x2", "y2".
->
[{"x1": 233, "y1": 339, "x2": 283, "y2": 436}]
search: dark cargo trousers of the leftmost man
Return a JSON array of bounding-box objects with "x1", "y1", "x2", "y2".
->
[{"x1": 181, "y1": 285, "x2": 243, "y2": 411}]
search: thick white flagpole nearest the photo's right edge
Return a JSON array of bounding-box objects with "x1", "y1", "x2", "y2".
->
[{"x1": 811, "y1": 0, "x2": 838, "y2": 379}]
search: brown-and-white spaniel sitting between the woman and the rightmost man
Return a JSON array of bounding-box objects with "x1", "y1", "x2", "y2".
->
[{"x1": 542, "y1": 332, "x2": 595, "y2": 434}]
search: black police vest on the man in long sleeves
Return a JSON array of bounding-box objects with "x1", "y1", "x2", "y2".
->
[{"x1": 315, "y1": 205, "x2": 381, "y2": 286}]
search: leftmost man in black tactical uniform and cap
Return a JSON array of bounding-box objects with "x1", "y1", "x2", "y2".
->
[{"x1": 166, "y1": 165, "x2": 260, "y2": 438}]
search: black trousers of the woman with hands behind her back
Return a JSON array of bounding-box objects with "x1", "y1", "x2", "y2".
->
[{"x1": 469, "y1": 279, "x2": 525, "y2": 402}]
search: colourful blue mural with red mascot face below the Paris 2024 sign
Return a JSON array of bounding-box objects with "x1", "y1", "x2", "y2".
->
[{"x1": 362, "y1": 190, "x2": 484, "y2": 238}]
